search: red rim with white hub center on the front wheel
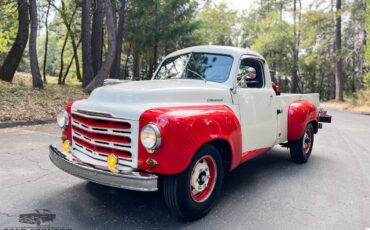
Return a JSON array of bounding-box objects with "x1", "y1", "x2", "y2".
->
[{"x1": 189, "y1": 155, "x2": 217, "y2": 203}]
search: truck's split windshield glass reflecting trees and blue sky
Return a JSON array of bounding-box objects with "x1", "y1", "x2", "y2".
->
[{"x1": 154, "y1": 53, "x2": 233, "y2": 83}]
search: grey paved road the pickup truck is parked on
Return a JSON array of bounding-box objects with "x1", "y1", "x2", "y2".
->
[{"x1": 0, "y1": 108, "x2": 370, "y2": 230}]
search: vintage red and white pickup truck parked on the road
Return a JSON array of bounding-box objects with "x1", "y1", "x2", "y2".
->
[{"x1": 50, "y1": 46, "x2": 331, "y2": 220}]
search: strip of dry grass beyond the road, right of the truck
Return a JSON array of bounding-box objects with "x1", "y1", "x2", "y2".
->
[{"x1": 321, "y1": 90, "x2": 370, "y2": 114}]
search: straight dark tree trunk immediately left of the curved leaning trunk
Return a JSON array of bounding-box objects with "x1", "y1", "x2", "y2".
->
[{"x1": 91, "y1": 0, "x2": 104, "y2": 75}]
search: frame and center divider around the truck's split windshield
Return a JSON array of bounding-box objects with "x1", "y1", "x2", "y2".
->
[{"x1": 152, "y1": 51, "x2": 234, "y2": 83}]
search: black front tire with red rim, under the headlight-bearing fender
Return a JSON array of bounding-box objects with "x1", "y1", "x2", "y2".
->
[{"x1": 162, "y1": 145, "x2": 224, "y2": 221}]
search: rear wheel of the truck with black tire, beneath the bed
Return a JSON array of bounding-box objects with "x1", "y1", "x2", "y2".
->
[{"x1": 289, "y1": 123, "x2": 314, "y2": 164}]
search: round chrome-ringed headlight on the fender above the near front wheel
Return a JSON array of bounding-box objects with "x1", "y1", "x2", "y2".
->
[{"x1": 140, "y1": 124, "x2": 161, "y2": 150}]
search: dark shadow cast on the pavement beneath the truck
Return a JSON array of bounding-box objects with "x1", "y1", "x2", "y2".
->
[{"x1": 42, "y1": 148, "x2": 319, "y2": 229}]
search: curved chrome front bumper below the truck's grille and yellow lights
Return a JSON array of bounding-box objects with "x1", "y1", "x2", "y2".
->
[{"x1": 49, "y1": 145, "x2": 158, "y2": 192}]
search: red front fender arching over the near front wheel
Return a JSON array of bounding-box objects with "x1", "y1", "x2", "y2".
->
[{"x1": 138, "y1": 105, "x2": 242, "y2": 174}]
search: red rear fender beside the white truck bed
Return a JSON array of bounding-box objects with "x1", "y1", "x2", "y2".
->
[{"x1": 288, "y1": 100, "x2": 318, "y2": 141}]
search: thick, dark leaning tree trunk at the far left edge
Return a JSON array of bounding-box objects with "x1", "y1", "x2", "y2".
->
[{"x1": 0, "y1": 0, "x2": 30, "y2": 82}]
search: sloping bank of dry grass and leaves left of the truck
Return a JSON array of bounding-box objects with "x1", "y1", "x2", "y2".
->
[{"x1": 0, "y1": 73, "x2": 86, "y2": 122}]
